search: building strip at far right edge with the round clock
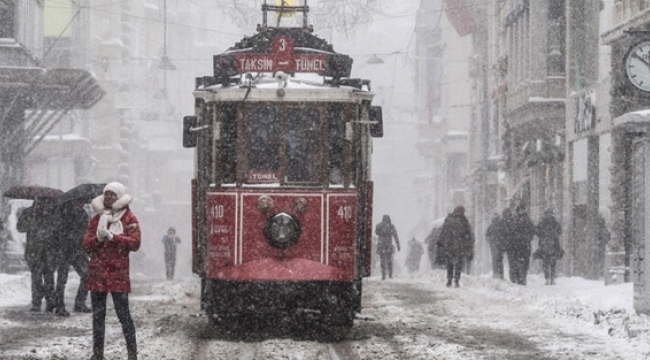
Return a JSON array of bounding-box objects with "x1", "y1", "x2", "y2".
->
[{"x1": 602, "y1": 0, "x2": 650, "y2": 313}]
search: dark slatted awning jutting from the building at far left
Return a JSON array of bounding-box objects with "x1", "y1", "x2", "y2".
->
[{"x1": 0, "y1": 67, "x2": 104, "y2": 110}]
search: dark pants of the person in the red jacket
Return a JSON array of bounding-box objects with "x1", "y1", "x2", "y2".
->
[{"x1": 90, "y1": 291, "x2": 138, "y2": 353}]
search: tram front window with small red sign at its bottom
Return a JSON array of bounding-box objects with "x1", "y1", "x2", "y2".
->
[{"x1": 247, "y1": 106, "x2": 282, "y2": 182}]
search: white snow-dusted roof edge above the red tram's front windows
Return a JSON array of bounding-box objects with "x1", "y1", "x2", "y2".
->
[{"x1": 194, "y1": 73, "x2": 374, "y2": 103}]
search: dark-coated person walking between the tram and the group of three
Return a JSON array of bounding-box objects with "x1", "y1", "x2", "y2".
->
[{"x1": 438, "y1": 206, "x2": 474, "y2": 287}]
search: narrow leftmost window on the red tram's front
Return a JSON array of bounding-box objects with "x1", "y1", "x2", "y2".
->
[{"x1": 220, "y1": 104, "x2": 237, "y2": 184}]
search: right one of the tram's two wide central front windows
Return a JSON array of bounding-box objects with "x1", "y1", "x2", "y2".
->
[{"x1": 285, "y1": 108, "x2": 321, "y2": 183}]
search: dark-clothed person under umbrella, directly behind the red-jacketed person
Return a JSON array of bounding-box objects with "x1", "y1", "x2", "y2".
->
[{"x1": 53, "y1": 200, "x2": 91, "y2": 316}]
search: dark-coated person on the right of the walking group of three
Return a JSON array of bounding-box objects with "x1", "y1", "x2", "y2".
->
[{"x1": 535, "y1": 209, "x2": 564, "y2": 285}]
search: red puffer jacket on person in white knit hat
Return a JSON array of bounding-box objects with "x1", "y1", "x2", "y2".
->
[{"x1": 83, "y1": 209, "x2": 141, "y2": 293}]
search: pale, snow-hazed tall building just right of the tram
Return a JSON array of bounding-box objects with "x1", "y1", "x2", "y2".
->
[{"x1": 415, "y1": 0, "x2": 470, "y2": 231}]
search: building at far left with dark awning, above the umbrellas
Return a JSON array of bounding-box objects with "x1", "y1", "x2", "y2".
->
[{"x1": 0, "y1": 0, "x2": 104, "y2": 192}]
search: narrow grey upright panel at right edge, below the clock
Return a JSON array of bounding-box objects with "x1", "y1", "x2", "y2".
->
[{"x1": 629, "y1": 138, "x2": 650, "y2": 314}]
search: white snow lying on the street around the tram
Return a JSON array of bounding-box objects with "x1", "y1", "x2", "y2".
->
[{"x1": 0, "y1": 270, "x2": 650, "y2": 360}]
